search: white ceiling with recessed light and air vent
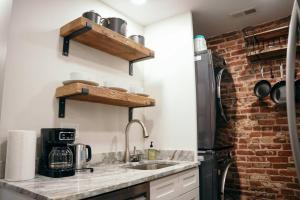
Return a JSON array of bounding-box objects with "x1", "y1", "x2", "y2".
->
[{"x1": 102, "y1": 0, "x2": 293, "y2": 36}]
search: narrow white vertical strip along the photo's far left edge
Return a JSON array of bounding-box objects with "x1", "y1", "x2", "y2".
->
[{"x1": 0, "y1": 0, "x2": 12, "y2": 119}]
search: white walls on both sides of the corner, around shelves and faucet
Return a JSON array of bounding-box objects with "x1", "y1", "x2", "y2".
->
[{"x1": 0, "y1": 0, "x2": 196, "y2": 174}]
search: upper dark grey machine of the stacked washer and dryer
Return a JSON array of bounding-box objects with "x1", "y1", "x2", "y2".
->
[{"x1": 195, "y1": 50, "x2": 233, "y2": 151}]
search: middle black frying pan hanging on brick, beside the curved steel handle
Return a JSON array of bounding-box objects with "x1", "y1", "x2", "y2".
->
[{"x1": 270, "y1": 64, "x2": 286, "y2": 104}]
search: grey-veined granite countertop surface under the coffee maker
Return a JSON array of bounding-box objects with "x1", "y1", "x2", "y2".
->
[{"x1": 0, "y1": 161, "x2": 198, "y2": 200}]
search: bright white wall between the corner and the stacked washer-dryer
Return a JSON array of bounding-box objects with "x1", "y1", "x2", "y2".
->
[{"x1": 144, "y1": 13, "x2": 197, "y2": 156}]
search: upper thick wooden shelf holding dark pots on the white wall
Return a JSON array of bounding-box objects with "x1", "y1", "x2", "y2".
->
[{"x1": 60, "y1": 17, "x2": 154, "y2": 61}]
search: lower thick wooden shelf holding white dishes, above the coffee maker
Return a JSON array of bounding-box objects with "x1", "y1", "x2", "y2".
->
[{"x1": 55, "y1": 83, "x2": 155, "y2": 108}]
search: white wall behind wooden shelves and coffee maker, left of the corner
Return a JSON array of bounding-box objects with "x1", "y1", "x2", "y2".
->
[{"x1": 0, "y1": 0, "x2": 148, "y2": 164}]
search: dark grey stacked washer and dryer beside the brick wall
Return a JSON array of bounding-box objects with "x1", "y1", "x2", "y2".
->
[{"x1": 195, "y1": 50, "x2": 234, "y2": 200}]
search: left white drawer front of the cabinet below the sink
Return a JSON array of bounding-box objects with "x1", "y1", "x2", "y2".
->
[{"x1": 150, "y1": 174, "x2": 181, "y2": 200}]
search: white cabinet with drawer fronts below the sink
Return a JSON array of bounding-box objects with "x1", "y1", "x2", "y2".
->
[{"x1": 150, "y1": 168, "x2": 199, "y2": 200}]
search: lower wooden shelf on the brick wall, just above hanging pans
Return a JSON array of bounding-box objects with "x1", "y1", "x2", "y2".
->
[{"x1": 247, "y1": 45, "x2": 300, "y2": 61}]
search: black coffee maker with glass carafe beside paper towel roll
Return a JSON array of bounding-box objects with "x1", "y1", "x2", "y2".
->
[{"x1": 38, "y1": 128, "x2": 75, "y2": 178}]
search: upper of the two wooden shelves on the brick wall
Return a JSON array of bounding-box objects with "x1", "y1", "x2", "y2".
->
[{"x1": 245, "y1": 26, "x2": 289, "y2": 42}]
